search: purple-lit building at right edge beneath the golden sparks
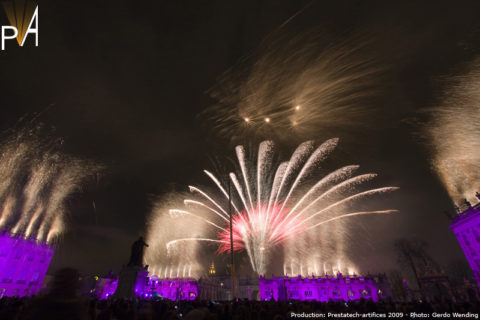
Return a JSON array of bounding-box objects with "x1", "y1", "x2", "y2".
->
[{"x1": 450, "y1": 202, "x2": 480, "y2": 286}]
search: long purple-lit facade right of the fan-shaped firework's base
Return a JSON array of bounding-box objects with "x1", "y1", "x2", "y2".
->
[{"x1": 259, "y1": 273, "x2": 378, "y2": 301}]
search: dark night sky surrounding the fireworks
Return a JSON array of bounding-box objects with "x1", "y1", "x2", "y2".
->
[{"x1": 0, "y1": 0, "x2": 480, "y2": 273}]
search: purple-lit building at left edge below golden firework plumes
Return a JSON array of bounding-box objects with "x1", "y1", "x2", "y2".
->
[{"x1": 0, "y1": 233, "x2": 53, "y2": 297}]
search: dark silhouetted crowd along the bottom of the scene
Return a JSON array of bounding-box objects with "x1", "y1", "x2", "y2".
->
[{"x1": 0, "y1": 269, "x2": 480, "y2": 320}]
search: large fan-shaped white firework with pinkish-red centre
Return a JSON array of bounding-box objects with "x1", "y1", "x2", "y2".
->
[{"x1": 146, "y1": 139, "x2": 397, "y2": 274}]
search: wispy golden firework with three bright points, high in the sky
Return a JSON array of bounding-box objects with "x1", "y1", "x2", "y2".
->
[{"x1": 202, "y1": 31, "x2": 386, "y2": 141}]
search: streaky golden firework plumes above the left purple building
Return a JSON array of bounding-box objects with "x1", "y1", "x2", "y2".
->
[{"x1": 0, "y1": 124, "x2": 101, "y2": 242}]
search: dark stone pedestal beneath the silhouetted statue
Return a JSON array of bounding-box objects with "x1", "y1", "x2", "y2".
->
[{"x1": 113, "y1": 266, "x2": 148, "y2": 299}]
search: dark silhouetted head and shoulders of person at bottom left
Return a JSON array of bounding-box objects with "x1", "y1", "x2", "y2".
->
[{"x1": 21, "y1": 268, "x2": 88, "y2": 320}]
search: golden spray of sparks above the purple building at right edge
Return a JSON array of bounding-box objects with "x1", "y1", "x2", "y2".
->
[{"x1": 425, "y1": 60, "x2": 480, "y2": 209}]
